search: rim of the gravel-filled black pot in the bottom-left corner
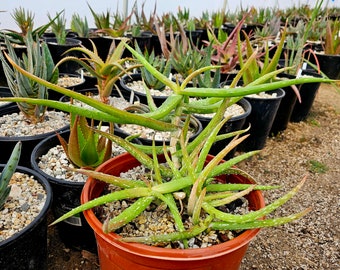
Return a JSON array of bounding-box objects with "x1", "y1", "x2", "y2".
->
[{"x1": 0, "y1": 164, "x2": 53, "y2": 250}]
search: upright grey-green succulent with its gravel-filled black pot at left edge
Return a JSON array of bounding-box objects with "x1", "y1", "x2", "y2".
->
[{"x1": 0, "y1": 32, "x2": 68, "y2": 167}]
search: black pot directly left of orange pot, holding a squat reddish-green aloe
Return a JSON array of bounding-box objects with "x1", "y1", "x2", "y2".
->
[{"x1": 31, "y1": 130, "x2": 96, "y2": 252}]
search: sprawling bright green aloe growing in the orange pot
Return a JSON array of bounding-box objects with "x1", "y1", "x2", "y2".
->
[{"x1": 1, "y1": 37, "x2": 332, "y2": 246}]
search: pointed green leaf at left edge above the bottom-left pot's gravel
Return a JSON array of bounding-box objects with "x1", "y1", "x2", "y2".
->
[{"x1": 0, "y1": 141, "x2": 21, "y2": 210}]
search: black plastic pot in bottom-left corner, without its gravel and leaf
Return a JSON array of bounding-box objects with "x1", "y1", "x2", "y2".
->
[{"x1": 0, "y1": 164, "x2": 52, "y2": 270}]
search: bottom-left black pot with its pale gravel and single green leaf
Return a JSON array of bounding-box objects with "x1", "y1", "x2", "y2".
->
[{"x1": 0, "y1": 142, "x2": 52, "y2": 269}]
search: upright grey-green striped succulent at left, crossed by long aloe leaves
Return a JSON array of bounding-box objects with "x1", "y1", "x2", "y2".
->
[{"x1": 0, "y1": 32, "x2": 59, "y2": 123}]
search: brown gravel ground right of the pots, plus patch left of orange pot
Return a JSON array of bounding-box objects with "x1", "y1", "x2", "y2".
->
[{"x1": 49, "y1": 85, "x2": 340, "y2": 270}]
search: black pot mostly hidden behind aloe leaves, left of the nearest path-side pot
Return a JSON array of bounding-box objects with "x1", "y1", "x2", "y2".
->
[{"x1": 195, "y1": 98, "x2": 251, "y2": 159}]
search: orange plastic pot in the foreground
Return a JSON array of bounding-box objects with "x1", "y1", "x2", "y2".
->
[{"x1": 81, "y1": 153, "x2": 265, "y2": 270}]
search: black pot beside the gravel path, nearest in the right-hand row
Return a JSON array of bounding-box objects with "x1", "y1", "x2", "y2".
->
[{"x1": 237, "y1": 88, "x2": 285, "y2": 152}]
